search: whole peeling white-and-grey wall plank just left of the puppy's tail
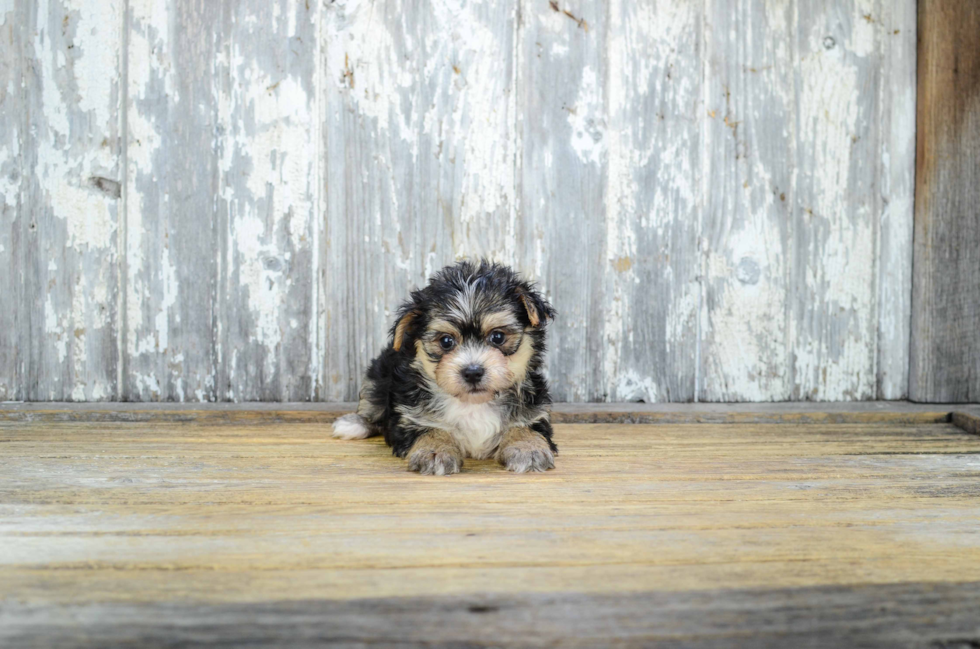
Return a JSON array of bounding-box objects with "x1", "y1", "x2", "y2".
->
[{"x1": 212, "y1": 0, "x2": 320, "y2": 401}]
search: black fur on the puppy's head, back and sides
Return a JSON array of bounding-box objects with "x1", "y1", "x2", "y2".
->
[{"x1": 358, "y1": 260, "x2": 558, "y2": 457}]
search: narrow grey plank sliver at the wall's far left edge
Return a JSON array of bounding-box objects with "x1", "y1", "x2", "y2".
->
[{"x1": 0, "y1": 0, "x2": 22, "y2": 401}]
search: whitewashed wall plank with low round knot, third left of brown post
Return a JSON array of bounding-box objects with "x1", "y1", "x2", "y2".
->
[{"x1": 698, "y1": 0, "x2": 799, "y2": 401}]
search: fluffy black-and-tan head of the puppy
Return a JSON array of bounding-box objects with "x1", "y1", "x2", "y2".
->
[{"x1": 391, "y1": 261, "x2": 555, "y2": 403}]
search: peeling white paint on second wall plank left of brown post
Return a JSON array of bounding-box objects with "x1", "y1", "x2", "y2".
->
[{"x1": 790, "y1": 14, "x2": 877, "y2": 400}]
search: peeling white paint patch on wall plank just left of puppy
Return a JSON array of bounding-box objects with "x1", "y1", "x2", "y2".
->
[{"x1": 217, "y1": 2, "x2": 320, "y2": 390}]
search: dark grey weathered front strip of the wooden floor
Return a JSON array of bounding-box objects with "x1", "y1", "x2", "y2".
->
[{"x1": 0, "y1": 582, "x2": 980, "y2": 649}]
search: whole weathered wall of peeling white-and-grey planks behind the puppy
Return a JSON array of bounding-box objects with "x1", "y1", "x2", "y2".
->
[{"x1": 0, "y1": 0, "x2": 916, "y2": 401}]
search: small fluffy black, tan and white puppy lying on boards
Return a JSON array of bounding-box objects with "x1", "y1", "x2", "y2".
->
[{"x1": 333, "y1": 260, "x2": 558, "y2": 475}]
